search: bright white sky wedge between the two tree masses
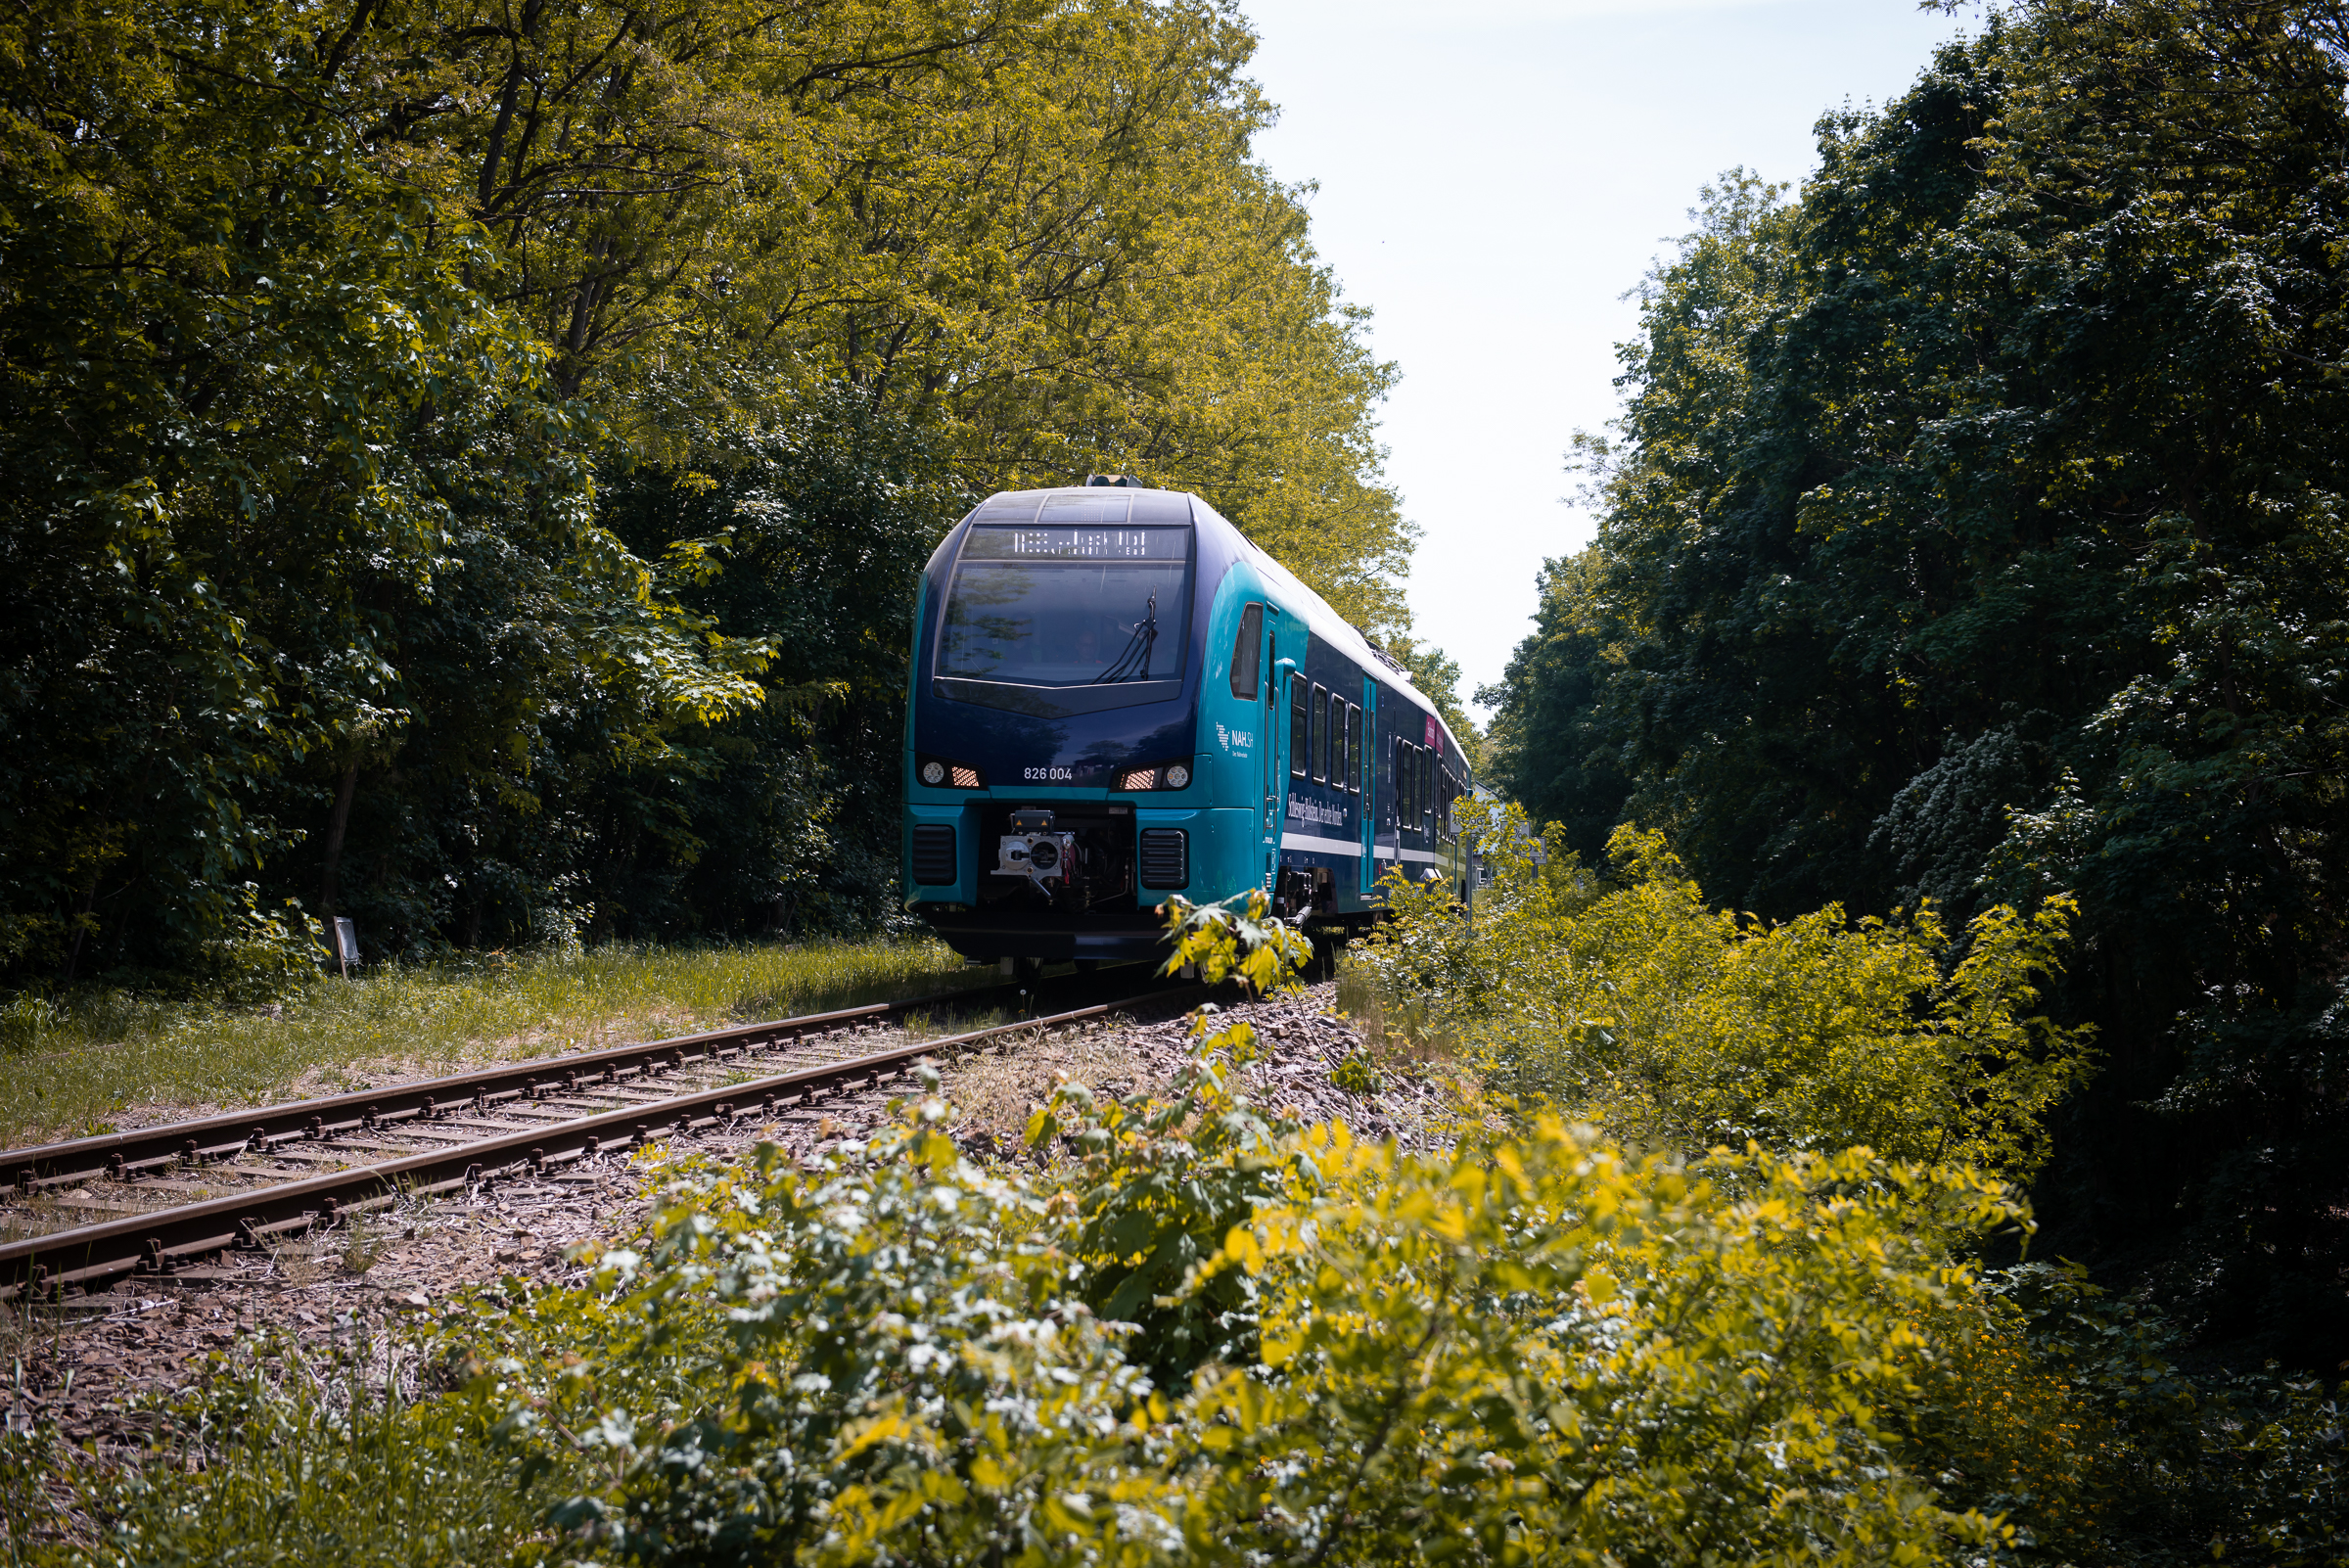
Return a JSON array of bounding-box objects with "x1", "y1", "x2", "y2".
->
[{"x1": 1243, "y1": 0, "x2": 1978, "y2": 720}]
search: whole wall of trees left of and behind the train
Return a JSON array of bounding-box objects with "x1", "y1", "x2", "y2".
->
[{"x1": 0, "y1": 0, "x2": 1414, "y2": 981}]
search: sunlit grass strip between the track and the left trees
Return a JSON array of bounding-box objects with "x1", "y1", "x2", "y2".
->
[{"x1": 0, "y1": 937, "x2": 989, "y2": 1145}]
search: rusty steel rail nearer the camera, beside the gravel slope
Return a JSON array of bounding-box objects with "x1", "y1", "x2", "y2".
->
[{"x1": 0, "y1": 986, "x2": 1183, "y2": 1301}]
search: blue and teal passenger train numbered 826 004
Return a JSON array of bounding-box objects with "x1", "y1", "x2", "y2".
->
[{"x1": 904, "y1": 477, "x2": 1470, "y2": 967}]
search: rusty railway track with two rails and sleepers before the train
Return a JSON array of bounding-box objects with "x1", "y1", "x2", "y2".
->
[{"x1": 0, "y1": 977, "x2": 1205, "y2": 1301}]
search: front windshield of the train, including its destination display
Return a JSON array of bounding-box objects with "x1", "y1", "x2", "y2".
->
[{"x1": 938, "y1": 526, "x2": 1191, "y2": 685}]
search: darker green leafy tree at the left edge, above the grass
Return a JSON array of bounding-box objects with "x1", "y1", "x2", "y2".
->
[{"x1": 0, "y1": 7, "x2": 757, "y2": 979}]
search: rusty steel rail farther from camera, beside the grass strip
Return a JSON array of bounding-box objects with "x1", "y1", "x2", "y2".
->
[{"x1": 0, "y1": 986, "x2": 1081, "y2": 1192}]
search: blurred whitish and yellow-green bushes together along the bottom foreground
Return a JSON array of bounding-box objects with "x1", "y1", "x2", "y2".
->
[{"x1": 448, "y1": 1051, "x2": 2010, "y2": 1563}]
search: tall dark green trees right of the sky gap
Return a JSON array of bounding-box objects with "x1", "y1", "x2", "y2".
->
[{"x1": 1510, "y1": 0, "x2": 2349, "y2": 1363}]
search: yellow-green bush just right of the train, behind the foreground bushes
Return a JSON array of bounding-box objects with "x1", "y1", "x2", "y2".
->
[{"x1": 1362, "y1": 807, "x2": 2091, "y2": 1178}]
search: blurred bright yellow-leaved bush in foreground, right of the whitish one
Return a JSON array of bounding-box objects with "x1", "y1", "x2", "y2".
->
[{"x1": 1193, "y1": 1118, "x2": 2006, "y2": 1563}]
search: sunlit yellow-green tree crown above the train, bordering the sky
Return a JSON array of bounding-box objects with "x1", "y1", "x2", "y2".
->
[{"x1": 345, "y1": 0, "x2": 1411, "y2": 626}]
